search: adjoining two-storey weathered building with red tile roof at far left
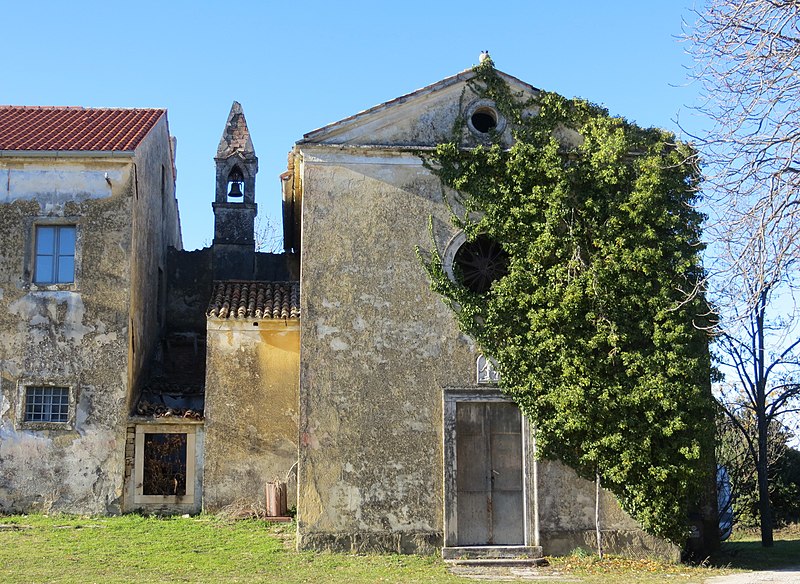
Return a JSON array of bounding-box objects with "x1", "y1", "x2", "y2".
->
[{"x1": 0, "y1": 106, "x2": 181, "y2": 513}]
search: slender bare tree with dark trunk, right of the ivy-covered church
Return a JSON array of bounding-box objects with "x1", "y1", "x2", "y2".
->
[{"x1": 709, "y1": 220, "x2": 800, "y2": 546}]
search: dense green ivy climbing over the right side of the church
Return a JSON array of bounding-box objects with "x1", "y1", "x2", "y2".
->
[{"x1": 420, "y1": 60, "x2": 714, "y2": 543}]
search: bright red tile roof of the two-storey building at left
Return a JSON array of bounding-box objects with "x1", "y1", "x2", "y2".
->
[{"x1": 0, "y1": 105, "x2": 166, "y2": 152}]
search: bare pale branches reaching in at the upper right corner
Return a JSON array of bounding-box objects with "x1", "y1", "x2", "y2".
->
[{"x1": 686, "y1": 0, "x2": 800, "y2": 264}]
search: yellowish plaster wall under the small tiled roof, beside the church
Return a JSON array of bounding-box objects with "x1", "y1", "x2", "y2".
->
[{"x1": 203, "y1": 318, "x2": 300, "y2": 511}]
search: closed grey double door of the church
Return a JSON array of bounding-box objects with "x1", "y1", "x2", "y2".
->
[{"x1": 456, "y1": 402, "x2": 525, "y2": 545}]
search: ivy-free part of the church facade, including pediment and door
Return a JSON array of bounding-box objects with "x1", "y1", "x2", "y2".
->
[{"x1": 285, "y1": 70, "x2": 676, "y2": 557}]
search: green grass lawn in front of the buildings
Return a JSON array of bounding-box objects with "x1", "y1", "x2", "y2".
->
[{"x1": 0, "y1": 515, "x2": 800, "y2": 584}]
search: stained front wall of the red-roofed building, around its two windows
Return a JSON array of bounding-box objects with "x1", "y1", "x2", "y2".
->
[{"x1": 0, "y1": 157, "x2": 135, "y2": 513}]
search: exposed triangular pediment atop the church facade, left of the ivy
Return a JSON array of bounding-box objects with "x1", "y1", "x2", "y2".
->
[{"x1": 298, "y1": 69, "x2": 538, "y2": 147}]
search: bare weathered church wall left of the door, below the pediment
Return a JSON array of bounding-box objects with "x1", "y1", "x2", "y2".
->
[{"x1": 298, "y1": 146, "x2": 475, "y2": 552}]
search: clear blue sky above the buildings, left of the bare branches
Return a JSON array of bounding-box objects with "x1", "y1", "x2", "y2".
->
[{"x1": 0, "y1": 0, "x2": 708, "y2": 249}]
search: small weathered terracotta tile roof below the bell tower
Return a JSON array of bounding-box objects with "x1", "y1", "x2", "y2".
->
[{"x1": 206, "y1": 282, "x2": 300, "y2": 320}]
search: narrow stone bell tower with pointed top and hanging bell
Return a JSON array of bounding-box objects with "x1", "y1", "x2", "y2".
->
[{"x1": 212, "y1": 101, "x2": 258, "y2": 280}]
